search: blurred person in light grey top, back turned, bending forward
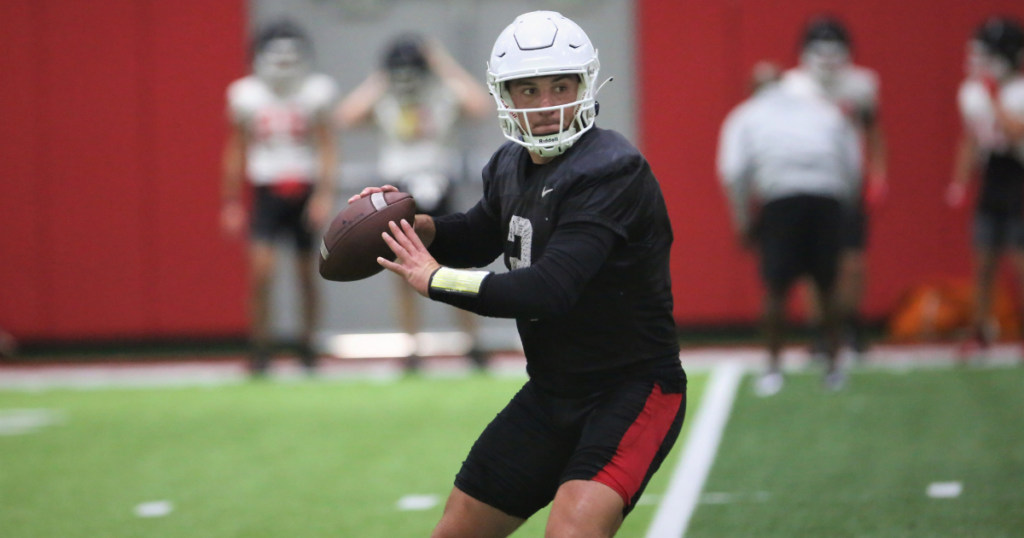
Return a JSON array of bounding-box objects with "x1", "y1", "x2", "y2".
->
[{"x1": 718, "y1": 67, "x2": 861, "y2": 396}]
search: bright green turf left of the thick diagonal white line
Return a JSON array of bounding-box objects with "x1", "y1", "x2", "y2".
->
[{"x1": 0, "y1": 370, "x2": 705, "y2": 538}]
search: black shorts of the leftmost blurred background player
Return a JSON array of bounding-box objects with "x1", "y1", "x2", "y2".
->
[{"x1": 249, "y1": 183, "x2": 313, "y2": 252}]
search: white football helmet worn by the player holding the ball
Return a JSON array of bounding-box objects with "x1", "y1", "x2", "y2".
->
[{"x1": 487, "y1": 11, "x2": 601, "y2": 157}]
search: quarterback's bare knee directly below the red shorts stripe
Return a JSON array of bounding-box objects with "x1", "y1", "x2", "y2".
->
[{"x1": 545, "y1": 480, "x2": 624, "y2": 538}]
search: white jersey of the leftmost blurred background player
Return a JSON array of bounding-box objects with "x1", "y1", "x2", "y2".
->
[{"x1": 227, "y1": 74, "x2": 338, "y2": 185}]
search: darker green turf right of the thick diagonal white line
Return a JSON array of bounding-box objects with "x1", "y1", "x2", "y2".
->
[{"x1": 686, "y1": 368, "x2": 1024, "y2": 538}]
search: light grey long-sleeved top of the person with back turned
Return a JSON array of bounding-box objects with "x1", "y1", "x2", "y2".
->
[{"x1": 718, "y1": 79, "x2": 861, "y2": 226}]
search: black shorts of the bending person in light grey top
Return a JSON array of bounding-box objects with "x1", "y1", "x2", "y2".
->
[{"x1": 757, "y1": 195, "x2": 846, "y2": 294}]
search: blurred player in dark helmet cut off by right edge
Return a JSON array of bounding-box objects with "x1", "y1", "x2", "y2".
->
[{"x1": 946, "y1": 17, "x2": 1024, "y2": 358}]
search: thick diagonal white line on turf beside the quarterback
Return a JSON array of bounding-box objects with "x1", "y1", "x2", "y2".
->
[{"x1": 647, "y1": 362, "x2": 744, "y2": 538}]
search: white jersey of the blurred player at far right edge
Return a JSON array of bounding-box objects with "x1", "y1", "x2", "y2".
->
[{"x1": 956, "y1": 75, "x2": 1024, "y2": 161}]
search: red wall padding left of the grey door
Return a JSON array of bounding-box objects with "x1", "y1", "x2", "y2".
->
[{"x1": 0, "y1": 0, "x2": 246, "y2": 339}]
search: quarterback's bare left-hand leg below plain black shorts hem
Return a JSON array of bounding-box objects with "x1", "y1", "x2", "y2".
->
[{"x1": 430, "y1": 488, "x2": 525, "y2": 538}]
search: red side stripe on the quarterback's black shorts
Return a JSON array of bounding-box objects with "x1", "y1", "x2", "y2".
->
[{"x1": 592, "y1": 383, "x2": 683, "y2": 506}]
